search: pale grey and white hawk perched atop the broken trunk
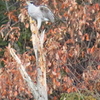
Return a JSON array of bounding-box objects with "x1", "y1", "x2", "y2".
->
[{"x1": 26, "y1": 1, "x2": 54, "y2": 29}]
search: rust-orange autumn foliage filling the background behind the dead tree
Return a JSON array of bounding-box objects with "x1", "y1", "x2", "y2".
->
[{"x1": 0, "y1": 0, "x2": 100, "y2": 100}]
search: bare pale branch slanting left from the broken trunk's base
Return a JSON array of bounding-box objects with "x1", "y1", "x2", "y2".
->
[{"x1": 8, "y1": 44, "x2": 38, "y2": 100}]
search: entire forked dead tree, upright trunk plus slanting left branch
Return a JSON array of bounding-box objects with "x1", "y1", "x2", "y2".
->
[{"x1": 8, "y1": 18, "x2": 48, "y2": 100}]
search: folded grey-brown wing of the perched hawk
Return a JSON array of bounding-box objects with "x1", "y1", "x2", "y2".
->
[{"x1": 39, "y1": 6, "x2": 54, "y2": 22}]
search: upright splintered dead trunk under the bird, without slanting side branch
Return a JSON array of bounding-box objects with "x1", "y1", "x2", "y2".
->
[{"x1": 30, "y1": 18, "x2": 48, "y2": 100}]
